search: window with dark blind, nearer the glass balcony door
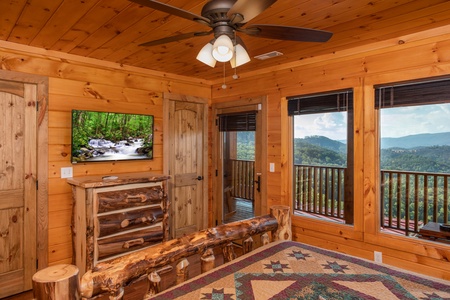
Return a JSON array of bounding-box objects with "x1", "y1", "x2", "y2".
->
[{"x1": 288, "y1": 90, "x2": 353, "y2": 224}]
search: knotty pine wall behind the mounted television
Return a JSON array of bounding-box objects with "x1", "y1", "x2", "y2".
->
[{"x1": 0, "y1": 42, "x2": 211, "y2": 265}]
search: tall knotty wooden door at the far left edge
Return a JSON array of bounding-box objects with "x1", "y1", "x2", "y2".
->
[{"x1": 0, "y1": 80, "x2": 37, "y2": 298}]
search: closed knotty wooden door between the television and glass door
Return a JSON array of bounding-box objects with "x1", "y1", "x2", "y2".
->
[{"x1": 165, "y1": 95, "x2": 208, "y2": 237}]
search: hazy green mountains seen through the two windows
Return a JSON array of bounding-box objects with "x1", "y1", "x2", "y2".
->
[{"x1": 294, "y1": 132, "x2": 450, "y2": 173}]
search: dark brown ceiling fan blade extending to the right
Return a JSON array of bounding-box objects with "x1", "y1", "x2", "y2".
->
[{"x1": 239, "y1": 25, "x2": 333, "y2": 43}]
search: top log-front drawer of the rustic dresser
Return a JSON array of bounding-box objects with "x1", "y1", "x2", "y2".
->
[{"x1": 97, "y1": 185, "x2": 166, "y2": 213}]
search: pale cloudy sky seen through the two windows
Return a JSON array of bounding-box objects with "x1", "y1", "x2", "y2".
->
[{"x1": 294, "y1": 104, "x2": 450, "y2": 140}]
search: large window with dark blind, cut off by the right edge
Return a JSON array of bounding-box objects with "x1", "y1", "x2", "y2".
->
[{"x1": 375, "y1": 80, "x2": 450, "y2": 236}]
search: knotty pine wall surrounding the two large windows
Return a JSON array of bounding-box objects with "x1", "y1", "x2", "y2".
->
[{"x1": 212, "y1": 26, "x2": 450, "y2": 280}]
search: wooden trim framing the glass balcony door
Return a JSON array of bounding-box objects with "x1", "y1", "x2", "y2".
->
[{"x1": 211, "y1": 96, "x2": 267, "y2": 226}]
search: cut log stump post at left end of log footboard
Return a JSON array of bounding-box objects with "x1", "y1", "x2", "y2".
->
[{"x1": 33, "y1": 264, "x2": 80, "y2": 300}]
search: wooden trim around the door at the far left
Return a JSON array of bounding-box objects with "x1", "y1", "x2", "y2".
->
[{"x1": 0, "y1": 70, "x2": 48, "y2": 284}]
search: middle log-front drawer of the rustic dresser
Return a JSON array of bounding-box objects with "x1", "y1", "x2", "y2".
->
[{"x1": 97, "y1": 205, "x2": 164, "y2": 237}]
